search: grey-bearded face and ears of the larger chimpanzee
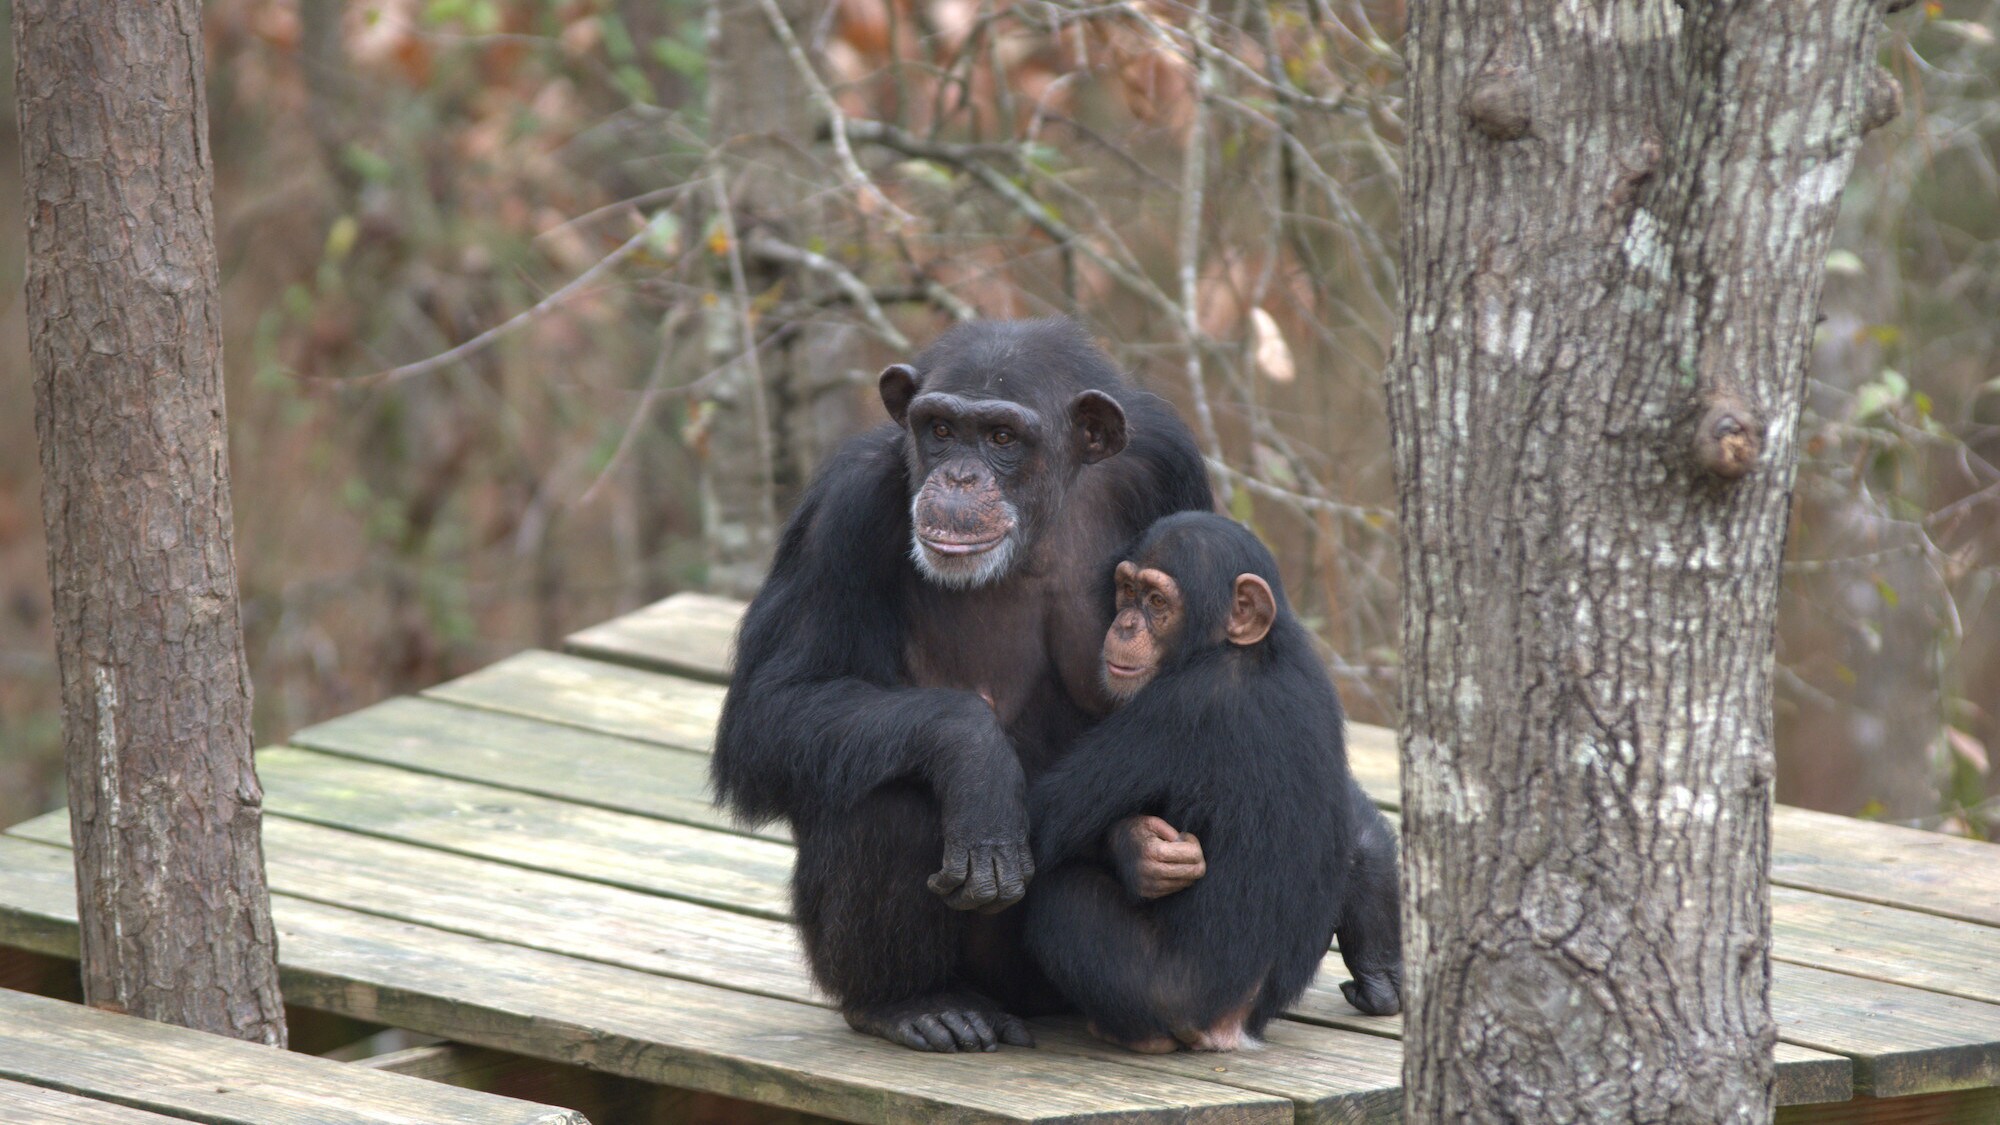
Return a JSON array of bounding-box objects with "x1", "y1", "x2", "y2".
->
[{"x1": 882, "y1": 364, "x2": 1124, "y2": 589}]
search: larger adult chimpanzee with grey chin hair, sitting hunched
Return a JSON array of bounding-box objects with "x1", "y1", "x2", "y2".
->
[{"x1": 714, "y1": 320, "x2": 1212, "y2": 1051}]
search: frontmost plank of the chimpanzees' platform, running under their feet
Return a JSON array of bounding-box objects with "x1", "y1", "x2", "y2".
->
[{"x1": 0, "y1": 837, "x2": 1292, "y2": 1125}]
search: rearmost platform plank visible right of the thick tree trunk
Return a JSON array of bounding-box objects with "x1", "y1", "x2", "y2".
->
[{"x1": 1770, "y1": 805, "x2": 2000, "y2": 927}]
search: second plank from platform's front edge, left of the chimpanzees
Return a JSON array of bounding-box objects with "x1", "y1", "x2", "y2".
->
[{"x1": 8, "y1": 811, "x2": 826, "y2": 1005}]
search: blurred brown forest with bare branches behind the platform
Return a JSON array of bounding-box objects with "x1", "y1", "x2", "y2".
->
[{"x1": 0, "y1": 0, "x2": 2000, "y2": 839}]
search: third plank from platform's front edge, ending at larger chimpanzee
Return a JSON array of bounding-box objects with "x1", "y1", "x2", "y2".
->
[{"x1": 258, "y1": 749, "x2": 792, "y2": 919}]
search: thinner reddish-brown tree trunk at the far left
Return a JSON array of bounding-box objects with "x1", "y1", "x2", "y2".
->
[{"x1": 14, "y1": 0, "x2": 284, "y2": 1043}]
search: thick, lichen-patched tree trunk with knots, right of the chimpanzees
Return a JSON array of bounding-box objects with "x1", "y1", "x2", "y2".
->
[{"x1": 1388, "y1": 0, "x2": 1894, "y2": 1123}]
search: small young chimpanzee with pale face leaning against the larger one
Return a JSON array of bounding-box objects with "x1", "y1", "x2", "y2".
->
[{"x1": 1026, "y1": 512, "x2": 1402, "y2": 1051}]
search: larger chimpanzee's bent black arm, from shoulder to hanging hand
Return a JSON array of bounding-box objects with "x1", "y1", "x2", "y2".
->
[{"x1": 710, "y1": 430, "x2": 1032, "y2": 909}]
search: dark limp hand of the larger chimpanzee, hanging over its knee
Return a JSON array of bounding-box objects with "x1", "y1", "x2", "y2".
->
[{"x1": 926, "y1": 735, "x2": 1034, "y2": 915}]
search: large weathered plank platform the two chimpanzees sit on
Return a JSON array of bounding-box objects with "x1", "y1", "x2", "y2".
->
[{"x1": 0, "y1": 595, "x2": 2000, "y2": 1123}]
